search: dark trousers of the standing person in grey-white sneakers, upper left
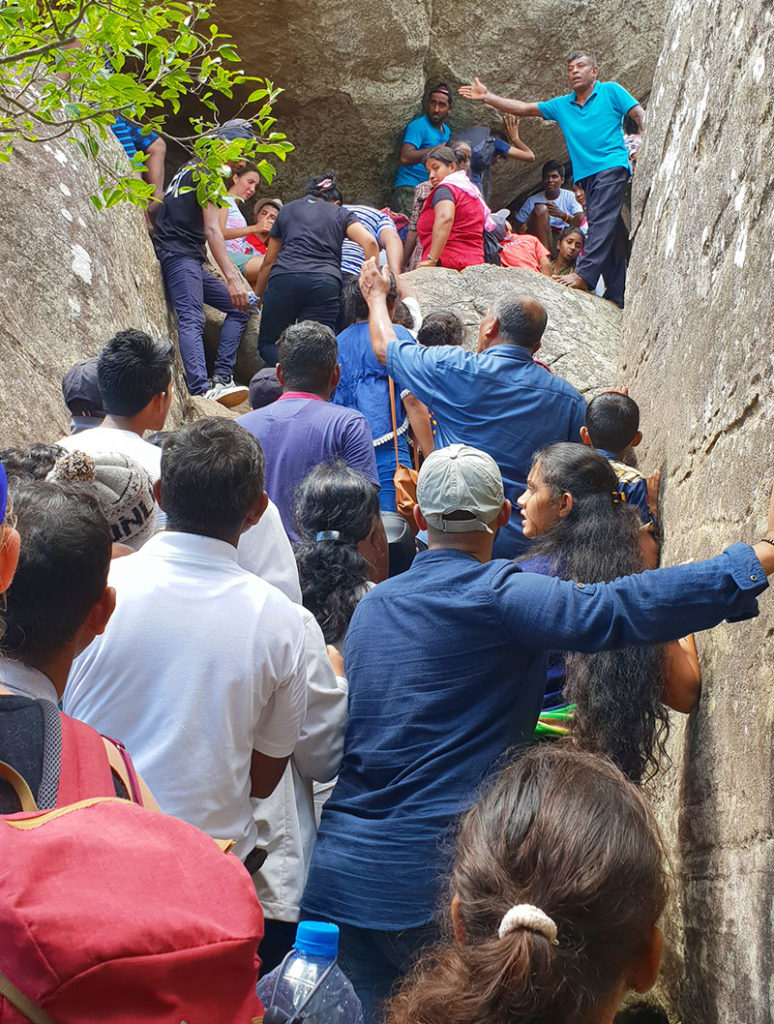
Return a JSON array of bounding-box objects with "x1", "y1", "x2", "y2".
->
[{"x1": 159, "y1": 253, "x2": 249, "y2": 394}]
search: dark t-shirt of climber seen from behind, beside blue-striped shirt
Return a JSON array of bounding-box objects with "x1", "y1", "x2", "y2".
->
[{"x1": 269, "y1": 196, "x2": 358, "y2": 280}]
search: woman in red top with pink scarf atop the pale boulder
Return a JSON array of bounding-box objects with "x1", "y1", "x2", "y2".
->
[{"x1": 417, "y1": 145, "x2": 486, "y2": 270}]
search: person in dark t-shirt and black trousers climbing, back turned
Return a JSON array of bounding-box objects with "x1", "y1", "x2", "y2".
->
[{"x1": 254, "y1": 171, "x2": 379, "y2": 366}]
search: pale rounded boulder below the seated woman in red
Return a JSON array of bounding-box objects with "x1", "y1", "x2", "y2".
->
[{"x1": 401, "y1": 264, "x2": 621, "y2": 397}]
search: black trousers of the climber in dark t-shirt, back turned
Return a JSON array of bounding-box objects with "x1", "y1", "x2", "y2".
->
[{"x1": 258, "y1": 273, "x2": 341, "y2": 367}]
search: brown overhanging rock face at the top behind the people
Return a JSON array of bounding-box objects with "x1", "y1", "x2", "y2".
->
[{"x1": 203, "y1": 0, "x2": 664, "y2": 206}]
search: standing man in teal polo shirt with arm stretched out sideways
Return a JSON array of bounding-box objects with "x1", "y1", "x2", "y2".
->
[{"x1": 460, "y1": 50, "x2": 645, "y2": 306}]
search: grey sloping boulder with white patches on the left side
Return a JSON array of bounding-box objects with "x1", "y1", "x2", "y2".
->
[{"x1": 0, "y1": 137, "x2": 247, "y2": 446}]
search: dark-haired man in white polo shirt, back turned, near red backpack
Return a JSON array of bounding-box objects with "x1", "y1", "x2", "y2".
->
[{"x1": 65, "y1": 419, "x2": 306, "y2": 871}]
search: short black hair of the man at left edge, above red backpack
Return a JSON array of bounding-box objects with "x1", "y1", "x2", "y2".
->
[{"x1": 2, "y1": 480, "x2": 112, "y2": 662}]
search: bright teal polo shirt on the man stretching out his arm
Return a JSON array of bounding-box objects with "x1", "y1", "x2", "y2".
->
[{"x1": 538, "y1": 82, "x2": 637, "y2": 181}]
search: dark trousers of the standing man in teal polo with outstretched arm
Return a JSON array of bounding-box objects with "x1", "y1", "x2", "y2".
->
[{"x1": 576, "y1": 167, "x2": 631, "y2": 308}]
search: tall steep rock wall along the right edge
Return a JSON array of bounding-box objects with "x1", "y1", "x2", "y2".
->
[{"x1": 622, "y1": 0, "x2": 774, "y2": 1024}]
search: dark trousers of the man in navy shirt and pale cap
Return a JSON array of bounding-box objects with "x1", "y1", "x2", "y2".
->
[{"x1": 339, "y1": 923, "x2": 440, "y2": 1024}]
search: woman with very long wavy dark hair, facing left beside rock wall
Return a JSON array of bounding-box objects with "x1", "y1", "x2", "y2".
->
[{"x1": 519, "y1": 442, "x2": 701, "y2": 781}]
